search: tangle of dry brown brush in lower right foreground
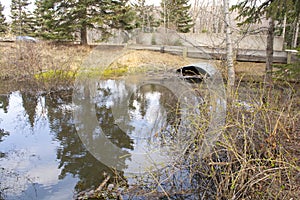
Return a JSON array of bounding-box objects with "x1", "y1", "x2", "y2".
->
[{"x1": 119, "y1": 83, "x2": 300, "y2": 200}]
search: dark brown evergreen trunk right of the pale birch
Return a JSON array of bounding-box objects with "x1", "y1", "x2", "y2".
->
[{"x1": 265, "y1": 18, "x2": 275, "y2": 85}]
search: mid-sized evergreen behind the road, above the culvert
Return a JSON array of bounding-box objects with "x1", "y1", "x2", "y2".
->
[{"x1": 161, "y1": 0, "x2": 194, "y2": 33}]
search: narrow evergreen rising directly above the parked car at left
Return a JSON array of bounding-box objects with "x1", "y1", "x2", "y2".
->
[{"x1": 10, "y1": 0, "x2": 34, "y2": 35}]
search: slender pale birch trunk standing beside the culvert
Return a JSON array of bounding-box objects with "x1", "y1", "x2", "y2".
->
[{"x1": 223, "y1": 0, "x2": 235, "y2": 95}]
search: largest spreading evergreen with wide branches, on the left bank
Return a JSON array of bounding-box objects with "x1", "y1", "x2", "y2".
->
[{"x1": 35, "y1": 0, "x2": 133, "y2": 44}]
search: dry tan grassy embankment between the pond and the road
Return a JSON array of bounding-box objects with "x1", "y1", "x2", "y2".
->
[{"x1": 0, "y1": 42, "x2": 265, "y2": 79}]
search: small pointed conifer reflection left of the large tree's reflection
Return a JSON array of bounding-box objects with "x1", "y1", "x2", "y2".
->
[{"x1": 21, "y1": 93, "x2": 38, "y2": 127}]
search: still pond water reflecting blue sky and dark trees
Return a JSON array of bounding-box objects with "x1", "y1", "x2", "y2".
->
[{"x1": 0, "y1": 77, "x2": 192, "y2": 199}]
